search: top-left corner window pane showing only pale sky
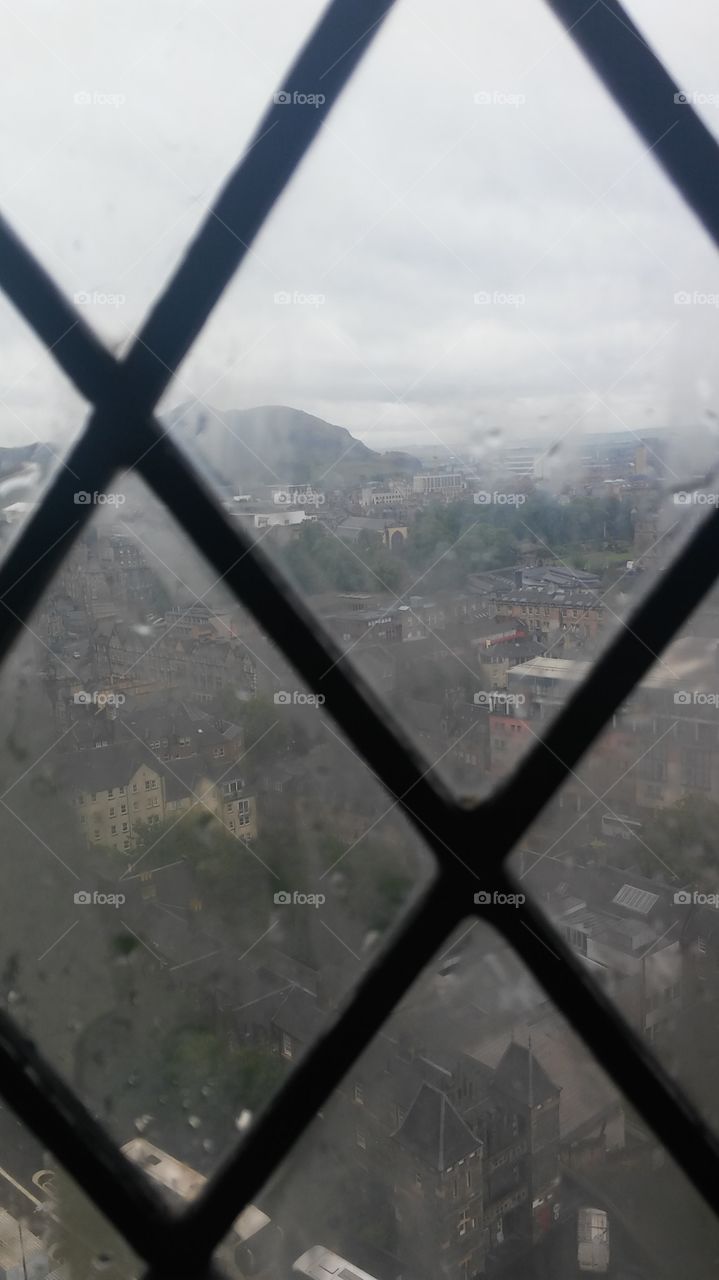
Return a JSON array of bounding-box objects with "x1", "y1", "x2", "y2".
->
[{"x1": 0, "y1": 0, "x2": 322, "y2": 344}]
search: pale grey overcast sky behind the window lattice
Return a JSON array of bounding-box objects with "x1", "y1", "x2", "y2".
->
[{"x1": 0, "y1": 0, "x2": 719, "y2": 453}]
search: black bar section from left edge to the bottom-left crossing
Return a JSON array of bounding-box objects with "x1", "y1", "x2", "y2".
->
[{"x1": 0, "y1": 1011, "x2": 174, "y2": 1261}]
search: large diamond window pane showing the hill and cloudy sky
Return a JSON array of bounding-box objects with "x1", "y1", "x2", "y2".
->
[{"x1": 152, "y1": 3, "x2": 719, "y2": 795}]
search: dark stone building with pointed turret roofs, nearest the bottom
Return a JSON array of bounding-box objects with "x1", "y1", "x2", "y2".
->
[{"x1": 339, "y1": 1036, "x2": 560, "y2": 1280}]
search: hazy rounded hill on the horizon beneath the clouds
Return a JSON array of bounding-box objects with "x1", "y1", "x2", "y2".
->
[{"x1": 165, "y1": 402, "x2": 422, "y2": 490}]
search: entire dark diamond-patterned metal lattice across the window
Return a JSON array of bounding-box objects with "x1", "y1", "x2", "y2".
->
[{"x1": 0, "y1": 0, "x2": 719, "y2": 1275}]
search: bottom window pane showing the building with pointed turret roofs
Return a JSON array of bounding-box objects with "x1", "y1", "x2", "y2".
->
[{"x1": 220, "y1": 908, "x2": 719, "y2": 1280}]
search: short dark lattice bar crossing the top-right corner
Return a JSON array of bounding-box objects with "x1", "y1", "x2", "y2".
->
[{"x1": 546, "y1": 0, "x2": 719, "y2": 244}]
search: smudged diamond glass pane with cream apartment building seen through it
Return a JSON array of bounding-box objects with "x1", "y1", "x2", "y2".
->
[{"x1": 0, "y1": 476, "x2": 432, "y2": 1172}]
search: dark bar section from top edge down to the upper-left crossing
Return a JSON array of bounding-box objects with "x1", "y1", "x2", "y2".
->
[{"x1": 119, "y1": 0, "x2": 394, "y2": 410}]
